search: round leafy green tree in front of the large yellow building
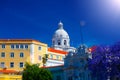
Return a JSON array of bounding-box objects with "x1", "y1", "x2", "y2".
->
[{"x1": 22, "y1": 63, "x2": 52, "y2": 80}]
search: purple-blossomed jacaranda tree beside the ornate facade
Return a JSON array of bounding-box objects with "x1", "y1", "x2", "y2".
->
[{"x1": 88, "y1": 43, "x2": 120, "y2": 80}]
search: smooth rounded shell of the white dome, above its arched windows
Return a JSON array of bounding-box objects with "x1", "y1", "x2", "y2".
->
[{"x1": 54, "y1": 29, "x2": 69, "y2": 38}]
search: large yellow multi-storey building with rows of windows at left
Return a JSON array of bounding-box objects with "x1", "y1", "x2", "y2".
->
[{"x1": 0, "y1": 39, "x2": 47, "y2": 71}]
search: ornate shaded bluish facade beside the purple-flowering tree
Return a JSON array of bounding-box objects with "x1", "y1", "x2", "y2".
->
[{"x1": 64, "y1": 45, "x2": 91, "y2": 80}]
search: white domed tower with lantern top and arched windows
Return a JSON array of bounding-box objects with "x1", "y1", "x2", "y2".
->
[{"x1": 52, "y1": 21, "x2": 70, "y2": 50}]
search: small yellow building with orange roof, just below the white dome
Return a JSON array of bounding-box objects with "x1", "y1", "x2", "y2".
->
[{"x1": 46, "y1": 48, "x2": 68, "y2": 66}]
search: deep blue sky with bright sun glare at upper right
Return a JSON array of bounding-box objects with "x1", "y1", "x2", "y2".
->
[{"x1": 0, "y1": 0, "x2": 120, "y2": 47}]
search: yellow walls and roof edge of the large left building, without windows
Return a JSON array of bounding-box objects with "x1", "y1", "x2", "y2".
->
[{"x1": 0, "y1": 40, "x2": 47, "y2": 71}]
